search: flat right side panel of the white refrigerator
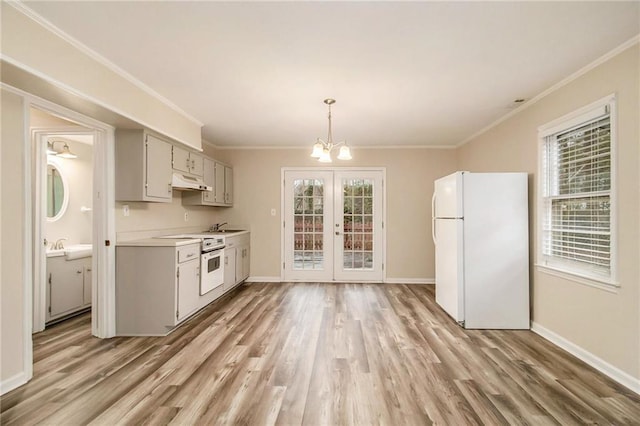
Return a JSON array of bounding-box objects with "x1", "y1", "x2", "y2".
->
[{"x1": 463, "y1": 173, "x2": 529, "y2": 329}]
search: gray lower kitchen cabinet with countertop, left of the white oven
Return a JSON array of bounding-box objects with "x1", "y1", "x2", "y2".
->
[{"x1": 116, "y1": 238, "x2": 203, "y2": 336}]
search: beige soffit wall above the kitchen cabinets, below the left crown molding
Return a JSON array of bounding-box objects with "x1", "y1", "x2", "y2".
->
[{"x1": 0, "y1": 2, "x2": 201, "y2": 149}]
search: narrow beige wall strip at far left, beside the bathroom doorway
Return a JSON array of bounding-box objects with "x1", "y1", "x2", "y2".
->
[{"x1": 0, "y1": 90, "x2": 26, "y2": 390}]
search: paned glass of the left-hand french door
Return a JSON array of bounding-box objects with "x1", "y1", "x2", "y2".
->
[{"x1": 293, "y1": 179, "x2": 324, "y2": 270}]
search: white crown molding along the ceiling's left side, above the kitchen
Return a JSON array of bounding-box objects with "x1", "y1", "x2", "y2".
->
[{"x1": 7, "y1": 1, "x2": 204, "y2": 127}]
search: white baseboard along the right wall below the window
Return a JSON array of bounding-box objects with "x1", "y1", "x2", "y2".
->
[{"x1": 531, "y1": 321, "x2": 640, "y2": 395}]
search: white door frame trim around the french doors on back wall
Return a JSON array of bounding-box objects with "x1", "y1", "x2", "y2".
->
[{"x1": 280, "y1": 167, "x2": 387, "y2": 283}]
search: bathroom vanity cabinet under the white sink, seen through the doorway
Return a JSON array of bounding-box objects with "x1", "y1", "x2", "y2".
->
[{"x1": 45, "y1": 256, "x2": 91, "y2": 322}]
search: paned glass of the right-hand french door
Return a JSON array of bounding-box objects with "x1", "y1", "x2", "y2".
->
[{"x1": 342, "y1": 179, "x2": 374, "y2": 270}]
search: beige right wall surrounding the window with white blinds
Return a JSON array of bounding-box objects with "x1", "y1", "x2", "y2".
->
[{"x1": 458, "y1": 44, "x2": 640, "y2": 378}]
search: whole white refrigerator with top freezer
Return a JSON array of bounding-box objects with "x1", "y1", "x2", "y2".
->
[{"x1": 432, "y1": 172, "x2": 529, "y2": 329}]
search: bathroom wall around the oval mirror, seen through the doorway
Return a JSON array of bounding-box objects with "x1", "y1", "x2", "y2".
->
[{"x1": 43, "y1": 137, "x2": 93, "y2": 246}]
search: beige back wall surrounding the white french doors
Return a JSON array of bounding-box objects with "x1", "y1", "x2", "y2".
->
[{"x1": 215, "y1": 146, "x2": 456, "y2": 282}]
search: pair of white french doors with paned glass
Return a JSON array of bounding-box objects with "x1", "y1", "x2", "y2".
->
[{"x1": 283, "y1": 169, "x2": 384, "y2": 282}]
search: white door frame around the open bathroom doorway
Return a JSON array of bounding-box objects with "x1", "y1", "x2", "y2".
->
[{"x1": 17, "y1": 86, "x2": 116, "y2": 344}]
